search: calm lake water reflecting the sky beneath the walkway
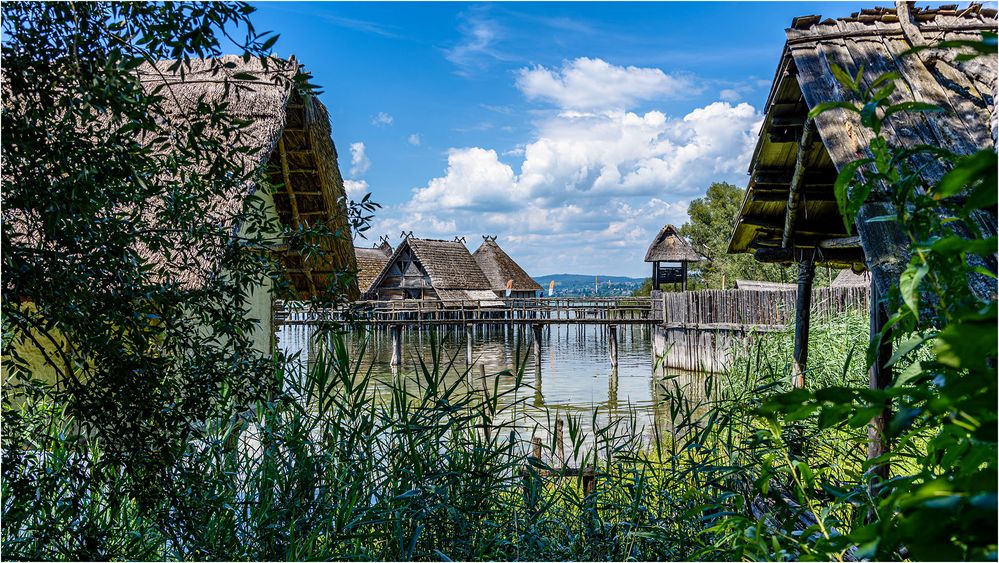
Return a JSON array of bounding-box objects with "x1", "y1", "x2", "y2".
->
[{"x1": 278, "y1": 324, "x2": 703, "y2": 456}]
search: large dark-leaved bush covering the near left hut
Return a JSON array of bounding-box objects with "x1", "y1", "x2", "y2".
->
[{"x1": 0, "y1": 2, "x2": 364, "y2": 502}]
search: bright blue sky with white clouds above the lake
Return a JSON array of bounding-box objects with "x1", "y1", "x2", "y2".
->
[{"x1": 255, "y1": 2, "x2": 952, "y2": 276}]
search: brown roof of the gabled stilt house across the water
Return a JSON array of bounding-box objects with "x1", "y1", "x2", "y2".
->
[{"x1": 371, "y1": 237, "x2": 491, "y2": 290}]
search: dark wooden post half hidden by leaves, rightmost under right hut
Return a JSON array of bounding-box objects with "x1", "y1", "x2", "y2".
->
[{"x1": 867, "y1": 283, "x2": 892, "y2": 496}]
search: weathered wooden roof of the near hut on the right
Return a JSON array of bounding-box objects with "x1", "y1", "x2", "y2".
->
[{"x1": 729, "y1": 2, "x2": 996, "y2": 276}]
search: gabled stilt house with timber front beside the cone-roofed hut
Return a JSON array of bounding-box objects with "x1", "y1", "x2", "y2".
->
[{"x1": 368, "y1": 237, "x2": 502, "y2": 306}]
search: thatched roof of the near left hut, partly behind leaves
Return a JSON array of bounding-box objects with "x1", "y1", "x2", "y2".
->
[{"x1": 137, "y1": 56, "x2": 356, "y2": 299}]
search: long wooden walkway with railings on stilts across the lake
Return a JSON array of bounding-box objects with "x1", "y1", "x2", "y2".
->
[{"x1": 274, "y1": 297, "x2": 661, "y2": 326}]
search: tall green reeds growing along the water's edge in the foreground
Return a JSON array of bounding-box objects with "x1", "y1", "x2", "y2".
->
[{"x1": 2, "y1": 315, "x2": 904, "y2": 560}]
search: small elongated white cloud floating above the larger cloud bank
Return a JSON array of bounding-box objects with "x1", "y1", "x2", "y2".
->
[{"x1": 517, "y1": 57, "x2": 693, "y2": 110}]
